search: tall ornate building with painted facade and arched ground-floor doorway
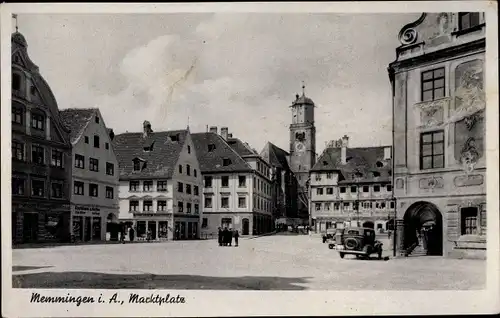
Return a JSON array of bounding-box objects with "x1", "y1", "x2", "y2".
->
[{"x1": 389, "y1": 12, "x2": 486, "y2": 257}]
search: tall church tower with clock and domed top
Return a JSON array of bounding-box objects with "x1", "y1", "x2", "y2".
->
[{"x1": 290, "y1": 86, "x2": 316, "y2": 187}]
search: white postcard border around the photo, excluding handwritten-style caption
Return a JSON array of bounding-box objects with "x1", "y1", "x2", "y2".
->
[{"x1": 0, "y1": 1, "x2": 500, "y2": 317}]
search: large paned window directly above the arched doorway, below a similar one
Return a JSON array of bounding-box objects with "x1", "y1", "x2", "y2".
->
[{"x1": 420, "y1": 130, "x2": 444, "y2": 169}]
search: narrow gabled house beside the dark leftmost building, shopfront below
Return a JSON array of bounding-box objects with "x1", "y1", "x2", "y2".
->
[{"x1": 60, "y1": 108, "x2": 119, "y2": 241}]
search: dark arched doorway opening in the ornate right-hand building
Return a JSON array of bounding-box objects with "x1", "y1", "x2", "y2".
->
[{"x1": 403, "y1": 202, "x2": 443, "y2": 255}]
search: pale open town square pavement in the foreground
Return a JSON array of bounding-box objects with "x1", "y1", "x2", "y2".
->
[{"x1": 12, "y1": 235, "x2": 486, "y2": 290}]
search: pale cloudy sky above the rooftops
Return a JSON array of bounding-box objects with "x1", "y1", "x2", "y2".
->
[{"x1": 12, "y1": 13, "x2": 420, "y2": 153}]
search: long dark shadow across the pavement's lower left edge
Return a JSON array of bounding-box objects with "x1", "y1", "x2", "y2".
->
[{"x1": 12, "y1": 272, "x2": 307, "y2": 290}]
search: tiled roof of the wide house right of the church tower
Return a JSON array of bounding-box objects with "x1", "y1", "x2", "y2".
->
[{"x1": 311, "y1": 147, "x2": 392, "y2": 183}]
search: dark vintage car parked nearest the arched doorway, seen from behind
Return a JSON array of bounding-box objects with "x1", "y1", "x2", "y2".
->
[{"x1": 335, "y1": 227, "x2": 383, "y2": 259}]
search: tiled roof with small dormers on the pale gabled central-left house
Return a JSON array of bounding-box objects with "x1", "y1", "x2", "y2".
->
[{"x1": 113, "y1": 130, "x2": 188, "y2": 179}]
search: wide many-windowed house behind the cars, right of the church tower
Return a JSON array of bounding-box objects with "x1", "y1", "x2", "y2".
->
[{"x1": 310, "y1": 136, "x2": 395, "y2": 232}]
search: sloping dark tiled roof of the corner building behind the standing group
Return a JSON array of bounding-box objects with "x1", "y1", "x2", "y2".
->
[{"x1": 191, "y1": 132, "x2": 252, "y2": 173}]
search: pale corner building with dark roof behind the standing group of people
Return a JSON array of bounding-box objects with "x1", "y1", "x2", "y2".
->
[{"x1": 193, "y1": 127, "x2": 273, "y2": 235}]
